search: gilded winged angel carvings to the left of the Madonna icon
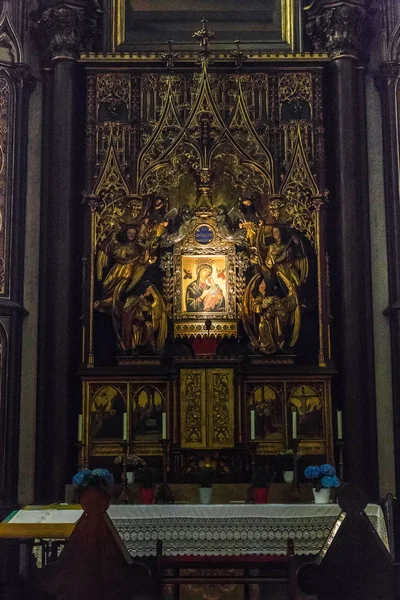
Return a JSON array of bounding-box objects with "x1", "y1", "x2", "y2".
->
[{"x1": 94, "y1": 216, "x2": 167, "y2": 352}]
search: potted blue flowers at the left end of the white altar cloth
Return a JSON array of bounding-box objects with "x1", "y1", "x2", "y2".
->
[{"x1": 72, "y1": 469, "x2": 114, "y2": 514}]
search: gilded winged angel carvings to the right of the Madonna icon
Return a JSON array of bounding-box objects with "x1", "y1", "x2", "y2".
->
[{"x1": 243, "y1": 226, "x2": 308, "y2": 354}]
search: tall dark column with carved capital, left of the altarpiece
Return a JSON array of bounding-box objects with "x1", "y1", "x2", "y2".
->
[{"x1": 35, "y1": 0, "x2": 97, "y2": 502}]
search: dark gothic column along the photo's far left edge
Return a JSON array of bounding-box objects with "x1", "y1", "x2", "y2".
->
[{"x1": 0, "y1": 8, "x2": 35, "y2": 519}]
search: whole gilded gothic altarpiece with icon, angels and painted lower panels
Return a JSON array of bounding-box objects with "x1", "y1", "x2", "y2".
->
[{"x1": 82, "y1": 56, "x2": 333, "y2": 480}]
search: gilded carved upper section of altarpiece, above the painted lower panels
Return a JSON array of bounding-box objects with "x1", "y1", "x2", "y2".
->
[{"x1": 88, "y1": 62, "x2": 323, "y2": 364}]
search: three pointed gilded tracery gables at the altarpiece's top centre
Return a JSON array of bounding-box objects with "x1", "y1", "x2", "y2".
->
[{"x1": 138, "y1": 70, "x2": 272, "y2": 199}]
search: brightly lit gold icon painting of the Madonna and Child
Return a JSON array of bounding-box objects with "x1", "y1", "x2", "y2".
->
[{"x1": 182, "y1": 257, "x2": 226, "y2": 313}]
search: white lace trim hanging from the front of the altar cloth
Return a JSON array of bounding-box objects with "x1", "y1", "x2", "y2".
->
[{"x1": 109, "y1": 506, "x2": 388, "y2": 556}]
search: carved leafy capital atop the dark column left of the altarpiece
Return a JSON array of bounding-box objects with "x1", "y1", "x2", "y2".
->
[{"x1": 33, "y1": 4, "x2": 100, "y2": 62}]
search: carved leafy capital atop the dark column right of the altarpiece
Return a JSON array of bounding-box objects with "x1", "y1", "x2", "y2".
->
[{"x1": 306, "y1": 3, "x2": 368, "y2": 58}]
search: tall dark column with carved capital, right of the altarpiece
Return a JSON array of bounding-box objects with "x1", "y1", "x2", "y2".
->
[{"x1": 306, "y1": 0, "x2": 378, "y2": 499}]
